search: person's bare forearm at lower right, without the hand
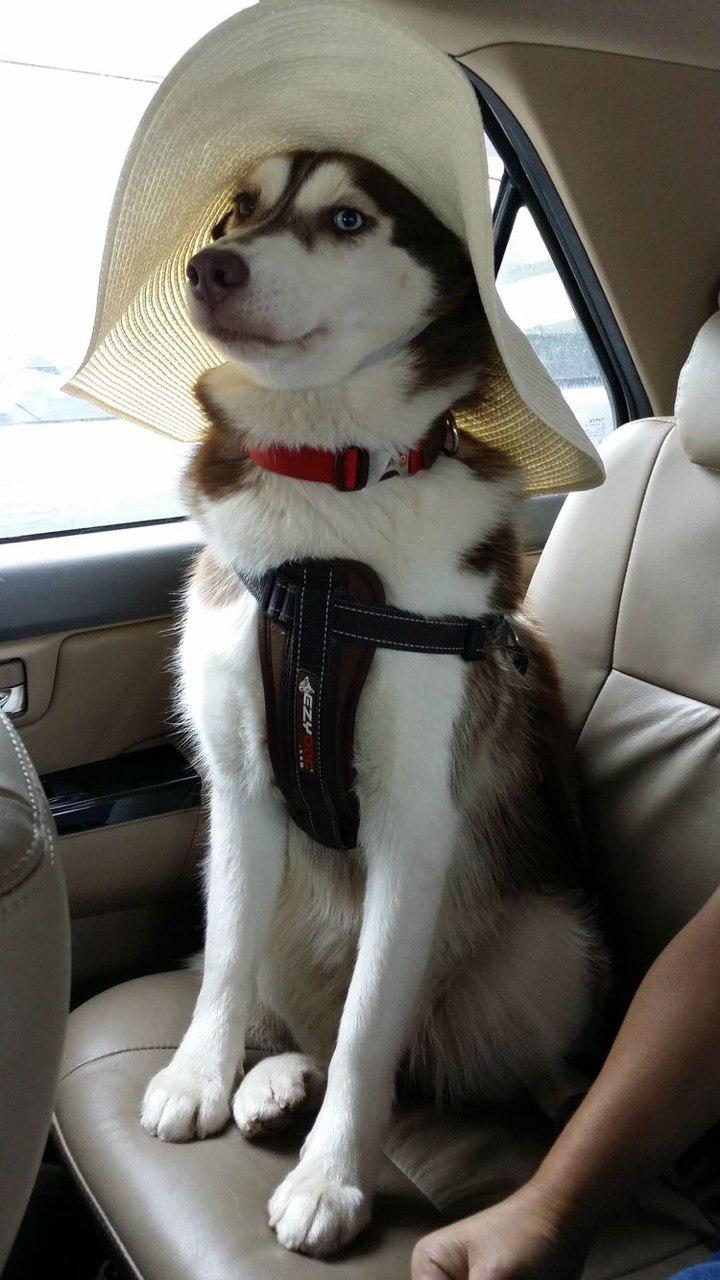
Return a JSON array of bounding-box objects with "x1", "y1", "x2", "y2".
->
[{"x1": 532, "y1": 892, "x2": 720, "y2": 1230}]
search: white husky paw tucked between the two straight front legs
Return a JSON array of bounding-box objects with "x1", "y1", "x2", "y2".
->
[{"x1": 232, "y1": 1053, "x2": 325, "y2": 1139}]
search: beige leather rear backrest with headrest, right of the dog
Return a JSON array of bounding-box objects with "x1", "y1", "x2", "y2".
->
[{"x1": 528, "y1": 304, "x2": 720, "y2": 973}]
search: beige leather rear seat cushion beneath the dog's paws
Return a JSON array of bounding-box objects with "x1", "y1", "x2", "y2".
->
[{"x1": 55, "y1": 972, "x2": 714, "y2": 1280}]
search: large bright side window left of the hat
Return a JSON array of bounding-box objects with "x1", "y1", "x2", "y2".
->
[{"x1": 0, "y1": 0, "x2": 252, "y2": 538}]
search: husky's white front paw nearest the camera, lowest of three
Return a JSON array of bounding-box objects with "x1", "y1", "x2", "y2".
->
[{"x1": 268, "y1": 1160, "x2": 370, "y2": 1258}]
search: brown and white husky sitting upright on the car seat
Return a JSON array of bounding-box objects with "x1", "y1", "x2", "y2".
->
[{"x1": 142, "y1": 152, "x2": 605, "y2": 1256}]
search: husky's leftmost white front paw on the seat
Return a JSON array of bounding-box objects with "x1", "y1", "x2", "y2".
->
[{"x1": 140, "y1": 1059, "x2": 231, "y2": 1142}]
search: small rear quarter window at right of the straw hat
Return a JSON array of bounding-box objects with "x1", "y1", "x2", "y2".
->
[{"x1": 497, "y1": 206, "x2": 615, "y2": 444}]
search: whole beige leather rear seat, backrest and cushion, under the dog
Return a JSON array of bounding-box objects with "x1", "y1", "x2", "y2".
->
[{"x1": 56, "y1": 316, "x2": 720, "y2": 1280}]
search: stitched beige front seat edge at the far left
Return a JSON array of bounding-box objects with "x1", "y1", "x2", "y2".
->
[{"x1": 0, "y1": 713, "x2": 70, "y2": 1272}]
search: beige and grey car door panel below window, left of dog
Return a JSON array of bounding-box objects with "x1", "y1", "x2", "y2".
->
[{"x1": 0, "y1": 524, "x2": 201, "y2": 998}]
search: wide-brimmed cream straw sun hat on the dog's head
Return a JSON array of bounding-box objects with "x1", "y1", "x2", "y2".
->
[{"x1": 67, "y1": 0, "x2": 603, "y2": 493}]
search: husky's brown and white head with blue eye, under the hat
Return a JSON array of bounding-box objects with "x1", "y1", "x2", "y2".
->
[{"x1": 187, "y1": 151, "x2": 479, "y2": 388}]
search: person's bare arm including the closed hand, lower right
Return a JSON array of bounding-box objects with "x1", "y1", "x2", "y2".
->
[{"x1": 411, "y1": 891, "x2": 720, "y2": 1280}]
